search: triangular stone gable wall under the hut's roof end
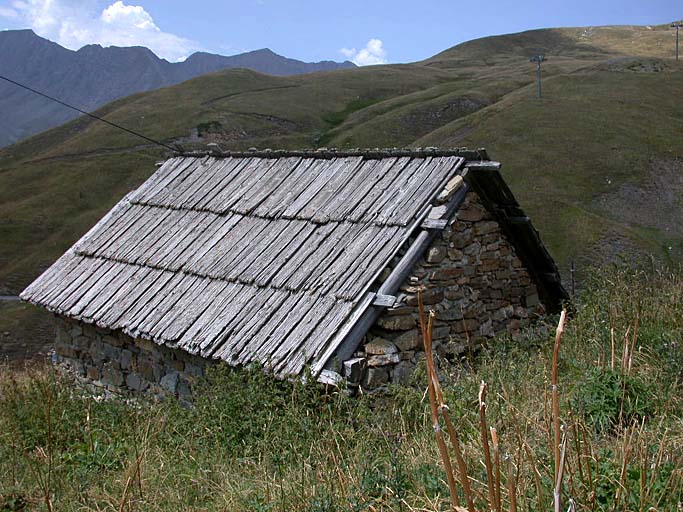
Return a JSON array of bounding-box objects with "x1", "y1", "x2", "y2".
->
[{"x1": 344, "y1": 192, "x2": 543, "y2": 390}]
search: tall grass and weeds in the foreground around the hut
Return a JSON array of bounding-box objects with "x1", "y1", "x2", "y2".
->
[{"x1": 0, "y1": 269, "x2": 683, "y2": 512}]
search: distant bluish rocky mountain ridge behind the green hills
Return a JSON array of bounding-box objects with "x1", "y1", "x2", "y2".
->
[{"x1": 0, "y1": 29, "x2": 355, "y2": 147}]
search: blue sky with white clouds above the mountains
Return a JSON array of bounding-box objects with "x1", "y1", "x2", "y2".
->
[{"x1": 0, "y1": 0, "x2": 683, "y2": 65}]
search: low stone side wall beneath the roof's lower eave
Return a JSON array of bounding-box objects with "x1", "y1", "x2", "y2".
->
[{"x1": 55, "y1": 317, "x2": 211, "y2": 400}]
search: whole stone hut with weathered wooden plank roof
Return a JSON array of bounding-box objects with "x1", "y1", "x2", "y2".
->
[{"x1": 21, "y1": 148, "x2": 567, "y2": 398}]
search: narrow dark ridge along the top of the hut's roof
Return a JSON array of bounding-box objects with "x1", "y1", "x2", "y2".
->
[{"x1": 175, "y1": 146, "x2": 489, "y2": 160}]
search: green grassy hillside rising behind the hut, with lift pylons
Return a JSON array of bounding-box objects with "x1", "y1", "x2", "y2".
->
[{"x1": 0, "y1": 26, "x2": 683, "y2": 304}]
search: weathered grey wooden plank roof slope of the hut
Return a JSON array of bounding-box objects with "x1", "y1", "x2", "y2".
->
[{"x1": 22, "y1": 150, "x2": 477, "y2": 376}]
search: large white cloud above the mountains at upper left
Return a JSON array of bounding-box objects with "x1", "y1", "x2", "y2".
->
[{"x1": 0, "y1": 0, "x2": 200, "y2": 61}]
